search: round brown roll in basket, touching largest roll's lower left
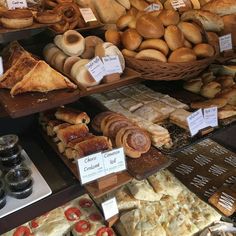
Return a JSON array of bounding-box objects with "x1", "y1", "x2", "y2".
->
[{"x1": 121, "y1": 29, "x2": 142, "y2": 51}]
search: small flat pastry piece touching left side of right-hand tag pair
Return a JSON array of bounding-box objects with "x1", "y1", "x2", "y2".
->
[{"x1": 170, "y1": 109, "x2": 191, "y2": 130}]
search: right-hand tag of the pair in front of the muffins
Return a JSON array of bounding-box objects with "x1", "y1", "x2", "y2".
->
[{"x1": 102, "y1": 55, "x2": 122, "y2": 75}]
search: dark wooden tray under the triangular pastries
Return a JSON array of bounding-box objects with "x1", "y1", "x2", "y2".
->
[{"x1": 0, "y1": 89, "x2": 80, "y2": 118}]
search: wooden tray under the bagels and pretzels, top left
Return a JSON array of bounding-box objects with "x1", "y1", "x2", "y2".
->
[{"x1": 0, "y1": 23, "x2": 51, "y2": 43}]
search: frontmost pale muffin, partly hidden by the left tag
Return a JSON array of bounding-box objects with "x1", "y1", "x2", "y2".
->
[{"x1": 71, "y1": 59, "x2": 99, "y2": 88}]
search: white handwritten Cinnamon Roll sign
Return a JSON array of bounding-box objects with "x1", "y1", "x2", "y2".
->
[{"x1": 102, "y1": 148, "x2": 126, "y2": 175}]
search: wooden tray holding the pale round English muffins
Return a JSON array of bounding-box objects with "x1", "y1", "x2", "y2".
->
[{"x1": 79, "y1": 67, "x2": 143, "y2": 97}]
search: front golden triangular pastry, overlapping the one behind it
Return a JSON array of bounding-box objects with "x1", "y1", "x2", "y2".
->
[{"x1": 11, "y1": 61, "x2": 77, "y2": 96}]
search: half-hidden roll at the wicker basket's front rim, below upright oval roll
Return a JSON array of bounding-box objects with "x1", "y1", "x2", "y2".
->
[{"x1": 168, "y1": 47, "x2": 197, "y2": 62}]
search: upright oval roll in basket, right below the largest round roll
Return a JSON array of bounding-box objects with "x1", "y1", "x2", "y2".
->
[{"x1": 164, "y1": 25, "x2": 184, "y2": 51}]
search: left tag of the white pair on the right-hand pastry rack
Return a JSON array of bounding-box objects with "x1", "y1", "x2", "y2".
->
[{"x1": 187, "y1": 109, "x2": 206, "y2": 136}]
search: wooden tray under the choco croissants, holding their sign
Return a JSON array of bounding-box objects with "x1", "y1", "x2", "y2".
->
[{"x1": 41, "y1": 131, "x2": 132, "y2": 198}]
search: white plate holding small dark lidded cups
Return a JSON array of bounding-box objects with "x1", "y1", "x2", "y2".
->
[{"x1": 0, "y1": 150, "x2": 52, "y2": 219}]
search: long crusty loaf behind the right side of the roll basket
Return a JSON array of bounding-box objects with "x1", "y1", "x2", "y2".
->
[{"x1": 181, "y1": 10, "x2": 224, "y2": 32}]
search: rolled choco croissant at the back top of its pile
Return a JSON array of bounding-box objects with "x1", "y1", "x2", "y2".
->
[{"x1": 55, "y1": 108, "x2": 90, "y2": 124}]
